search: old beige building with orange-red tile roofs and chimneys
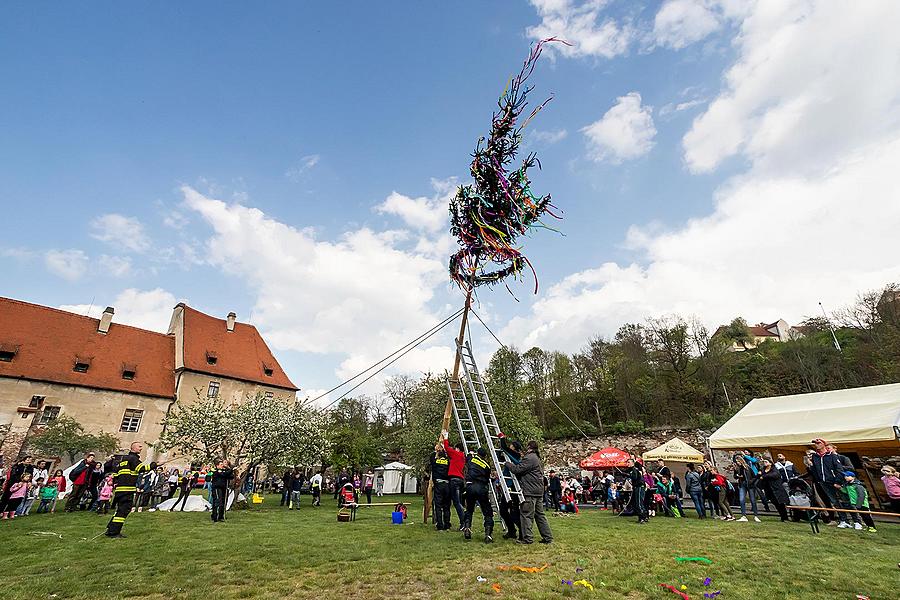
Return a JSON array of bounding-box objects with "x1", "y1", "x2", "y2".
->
[{"x1": 0, "y1": 298, "x2": 298, "y2": 465}]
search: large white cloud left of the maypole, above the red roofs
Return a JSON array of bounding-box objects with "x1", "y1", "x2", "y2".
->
[{"x1": 183, "y1": 187, "x2": 452, "y2": 385}]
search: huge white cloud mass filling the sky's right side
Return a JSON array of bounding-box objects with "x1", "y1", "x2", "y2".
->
[{"x1": 501, "y1": 1, "x2": 900, "y2": 350}]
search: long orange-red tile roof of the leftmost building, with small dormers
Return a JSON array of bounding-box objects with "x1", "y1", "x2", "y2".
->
[{"x1": 0, "y1": 297, "x2": 175, "y2": 402}]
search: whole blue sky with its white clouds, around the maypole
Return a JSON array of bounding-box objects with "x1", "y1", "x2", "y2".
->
[{"x1": 0, "y1": 0, "x2": 900, "y2": 404}]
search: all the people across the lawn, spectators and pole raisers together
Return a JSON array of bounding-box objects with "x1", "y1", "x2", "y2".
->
[{"x1": 0, "y1": 432, "x2": 900, "y2": 544}]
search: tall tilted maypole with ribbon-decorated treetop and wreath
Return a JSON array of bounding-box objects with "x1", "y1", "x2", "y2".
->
[{"x1": 424, "y1": 38, "x2": 569, "y2": 523}]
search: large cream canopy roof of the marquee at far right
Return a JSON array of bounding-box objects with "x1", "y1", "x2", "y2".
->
[{"x1": 709, "y1": 383, "x2": 900, "y2": 449}]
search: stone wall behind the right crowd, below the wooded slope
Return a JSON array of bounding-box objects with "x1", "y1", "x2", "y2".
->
[{"x1": 543, "y1": 429, "x2": 724, "y2": 472}]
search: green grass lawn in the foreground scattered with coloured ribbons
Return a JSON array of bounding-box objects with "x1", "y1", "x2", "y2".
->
[{"x1": 0, "y1": 496, "x2": 900, "y2": 600}]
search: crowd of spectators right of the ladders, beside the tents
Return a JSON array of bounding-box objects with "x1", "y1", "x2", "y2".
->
[{"x1": 545, "y1": 439, "x2": 900, "y2": 533}]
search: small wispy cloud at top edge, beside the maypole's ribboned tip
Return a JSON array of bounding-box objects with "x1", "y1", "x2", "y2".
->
[{"x1": 527, "y1": 0, "x2": 635, "y2": 58}]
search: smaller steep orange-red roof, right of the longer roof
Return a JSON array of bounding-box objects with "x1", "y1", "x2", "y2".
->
[{"x1": 183, "y1": 305, "x2": 298, "y2": 391}]
